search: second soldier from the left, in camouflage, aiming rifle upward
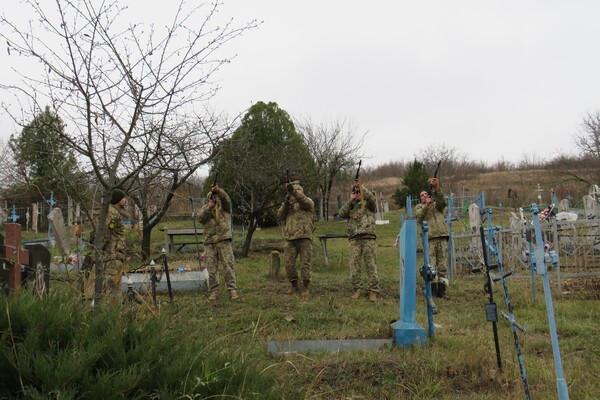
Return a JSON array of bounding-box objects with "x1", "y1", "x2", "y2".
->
[{"x1": 198, "y1": 184, "x2": 239, "y2": 301}]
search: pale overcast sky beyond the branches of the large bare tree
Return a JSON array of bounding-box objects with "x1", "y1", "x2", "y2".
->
[{"x1": 0, "y1": 0, "x2": 600, "y2": 166}]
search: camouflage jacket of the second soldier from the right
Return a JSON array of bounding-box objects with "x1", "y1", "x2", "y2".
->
[{"x1": 339, "y1": 185, "x2": 377, "y2": 240}]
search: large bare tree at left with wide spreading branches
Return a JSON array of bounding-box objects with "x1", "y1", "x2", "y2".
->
[{"x1": 0, "y1": 0, "x2": 258, "y2": 300}]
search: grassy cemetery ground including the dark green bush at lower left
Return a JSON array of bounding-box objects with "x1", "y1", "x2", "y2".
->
[{"x1": 0, "y1": 212, "x2": 600, "y2": 399}]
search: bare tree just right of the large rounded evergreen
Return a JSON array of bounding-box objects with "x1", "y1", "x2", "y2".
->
[{"x1": 295, "y1": 117, "x2": 368, "y2": 220}]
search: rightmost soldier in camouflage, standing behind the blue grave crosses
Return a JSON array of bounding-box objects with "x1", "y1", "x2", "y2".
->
[{"x1": 414, "y1": 178, "x2": 449, "y2": 297}]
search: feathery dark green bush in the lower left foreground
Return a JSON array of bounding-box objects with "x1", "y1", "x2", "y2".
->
[{"x1": 0, "y1": 292, "x2": 288, "y2": 399}]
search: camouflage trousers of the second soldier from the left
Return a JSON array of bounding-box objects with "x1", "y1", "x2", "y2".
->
[{"x1": 204, "y1": 240, "x2": 237, "y2": 293}]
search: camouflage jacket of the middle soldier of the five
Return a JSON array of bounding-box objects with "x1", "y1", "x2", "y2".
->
[{"x1": 277, "y1": 190, "x2": 315, "y2": 241}]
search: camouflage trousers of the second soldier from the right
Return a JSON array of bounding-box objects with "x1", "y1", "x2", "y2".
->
[{"x1": 348, "y1": 239, "x2": 381, "y2": 293}]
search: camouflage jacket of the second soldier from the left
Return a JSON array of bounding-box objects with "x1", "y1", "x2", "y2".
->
[{"x1": 198, "y1": 189, "x2": 232, "y2": 244}]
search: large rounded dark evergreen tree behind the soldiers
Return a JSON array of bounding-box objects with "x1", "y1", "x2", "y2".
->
[{"x1": 210, "y1": 101, "x2": 315, "y2": 256}]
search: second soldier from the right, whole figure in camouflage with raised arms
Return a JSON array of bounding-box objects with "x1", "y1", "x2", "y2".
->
[{"x1": 339, "y1": 179, "x2": 381, "y2": 301}]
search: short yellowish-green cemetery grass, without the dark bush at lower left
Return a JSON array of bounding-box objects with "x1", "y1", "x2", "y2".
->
[{"x1": 7, "y1": 212, "x2": 600, "y2": 400}]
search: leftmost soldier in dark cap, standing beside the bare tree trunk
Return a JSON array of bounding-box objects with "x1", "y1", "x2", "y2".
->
[{"x1": 100, "y1": 189, "x2": 127, "y2": 304}]
